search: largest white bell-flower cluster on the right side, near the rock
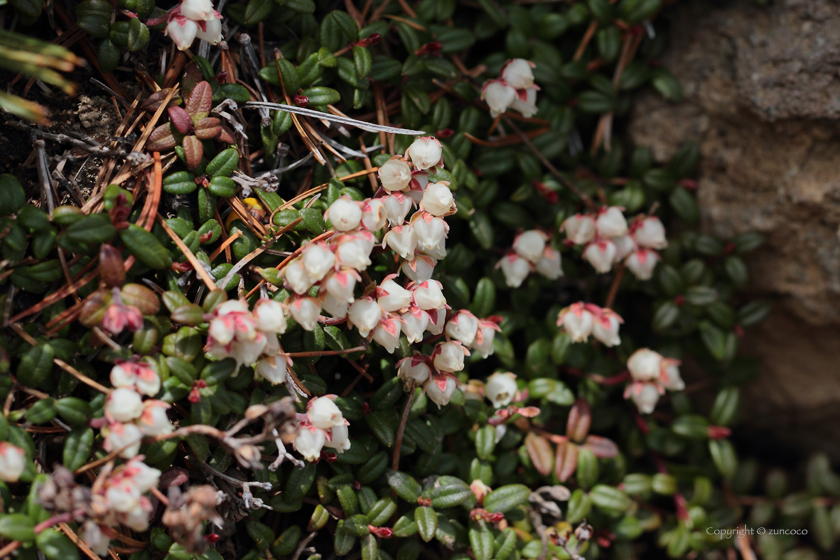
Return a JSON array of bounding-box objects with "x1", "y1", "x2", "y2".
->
[{"x1": 562, "y1": 206, "x2": 668, "y2": 280}]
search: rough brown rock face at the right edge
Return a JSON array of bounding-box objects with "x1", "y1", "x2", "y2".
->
[{"x1": 630, "y1": 0, "x2": 840, "y2": 459}]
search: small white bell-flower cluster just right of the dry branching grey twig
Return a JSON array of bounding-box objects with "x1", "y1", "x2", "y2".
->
[{"x1": 293, "y1": 395, "x2": 351, "y2": 462}]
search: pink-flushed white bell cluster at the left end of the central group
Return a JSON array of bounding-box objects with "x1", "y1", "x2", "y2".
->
[{"x1": 205, "y1": 298, "x2": 294, "y2": 383}]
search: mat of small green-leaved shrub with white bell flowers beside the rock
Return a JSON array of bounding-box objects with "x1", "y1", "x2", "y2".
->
[{"x1": 0, "y1": 0, "x2": 840, "y2": 560}]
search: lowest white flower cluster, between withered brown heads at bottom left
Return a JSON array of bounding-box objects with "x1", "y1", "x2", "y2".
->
[{"x1": 82, "y1": 457, "x2": 161, "y2": 556}]
